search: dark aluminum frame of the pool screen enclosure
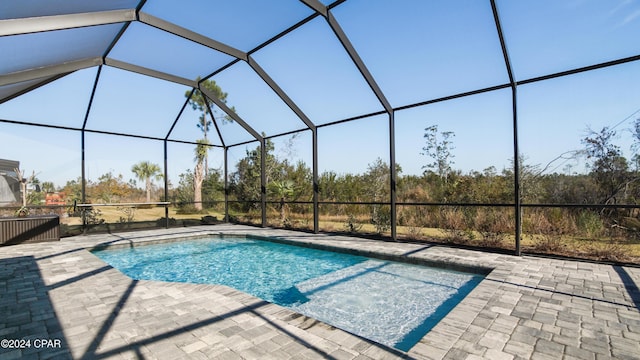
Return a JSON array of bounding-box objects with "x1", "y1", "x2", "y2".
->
[{"x1": 0, "y1": 0, "x2": 640, "y2": 255}]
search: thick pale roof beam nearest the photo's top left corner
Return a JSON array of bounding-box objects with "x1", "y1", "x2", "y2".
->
[{"x1": 0, "y1": 9, "x2": 136, "y2": 36}]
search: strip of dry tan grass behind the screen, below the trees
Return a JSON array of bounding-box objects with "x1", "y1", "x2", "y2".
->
[{"x1": 55, "y1": 207, "x2": 640, "y2": 263}]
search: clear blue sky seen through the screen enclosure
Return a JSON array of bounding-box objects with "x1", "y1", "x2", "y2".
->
[{"x1": 0, "y1": 0, "x2": 640, "y2": 186}]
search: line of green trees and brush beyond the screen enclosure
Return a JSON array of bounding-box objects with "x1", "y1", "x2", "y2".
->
[{"x1": 26, "y1": 80, "x2": 640, "y2": 250}]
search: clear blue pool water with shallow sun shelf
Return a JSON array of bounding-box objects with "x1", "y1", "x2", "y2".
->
[{"x1": 93, "y1": 238, "x2": 483, "y2": 351}]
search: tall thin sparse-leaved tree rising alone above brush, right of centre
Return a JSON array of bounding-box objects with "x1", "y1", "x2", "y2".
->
[{"x1": 420, "y1": 125, "x2": 455, "y2": 184}]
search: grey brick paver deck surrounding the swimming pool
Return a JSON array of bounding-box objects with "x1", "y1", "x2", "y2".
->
[{"x1": 0, "y1": 224, "x2": 640, "y2": 360}]
